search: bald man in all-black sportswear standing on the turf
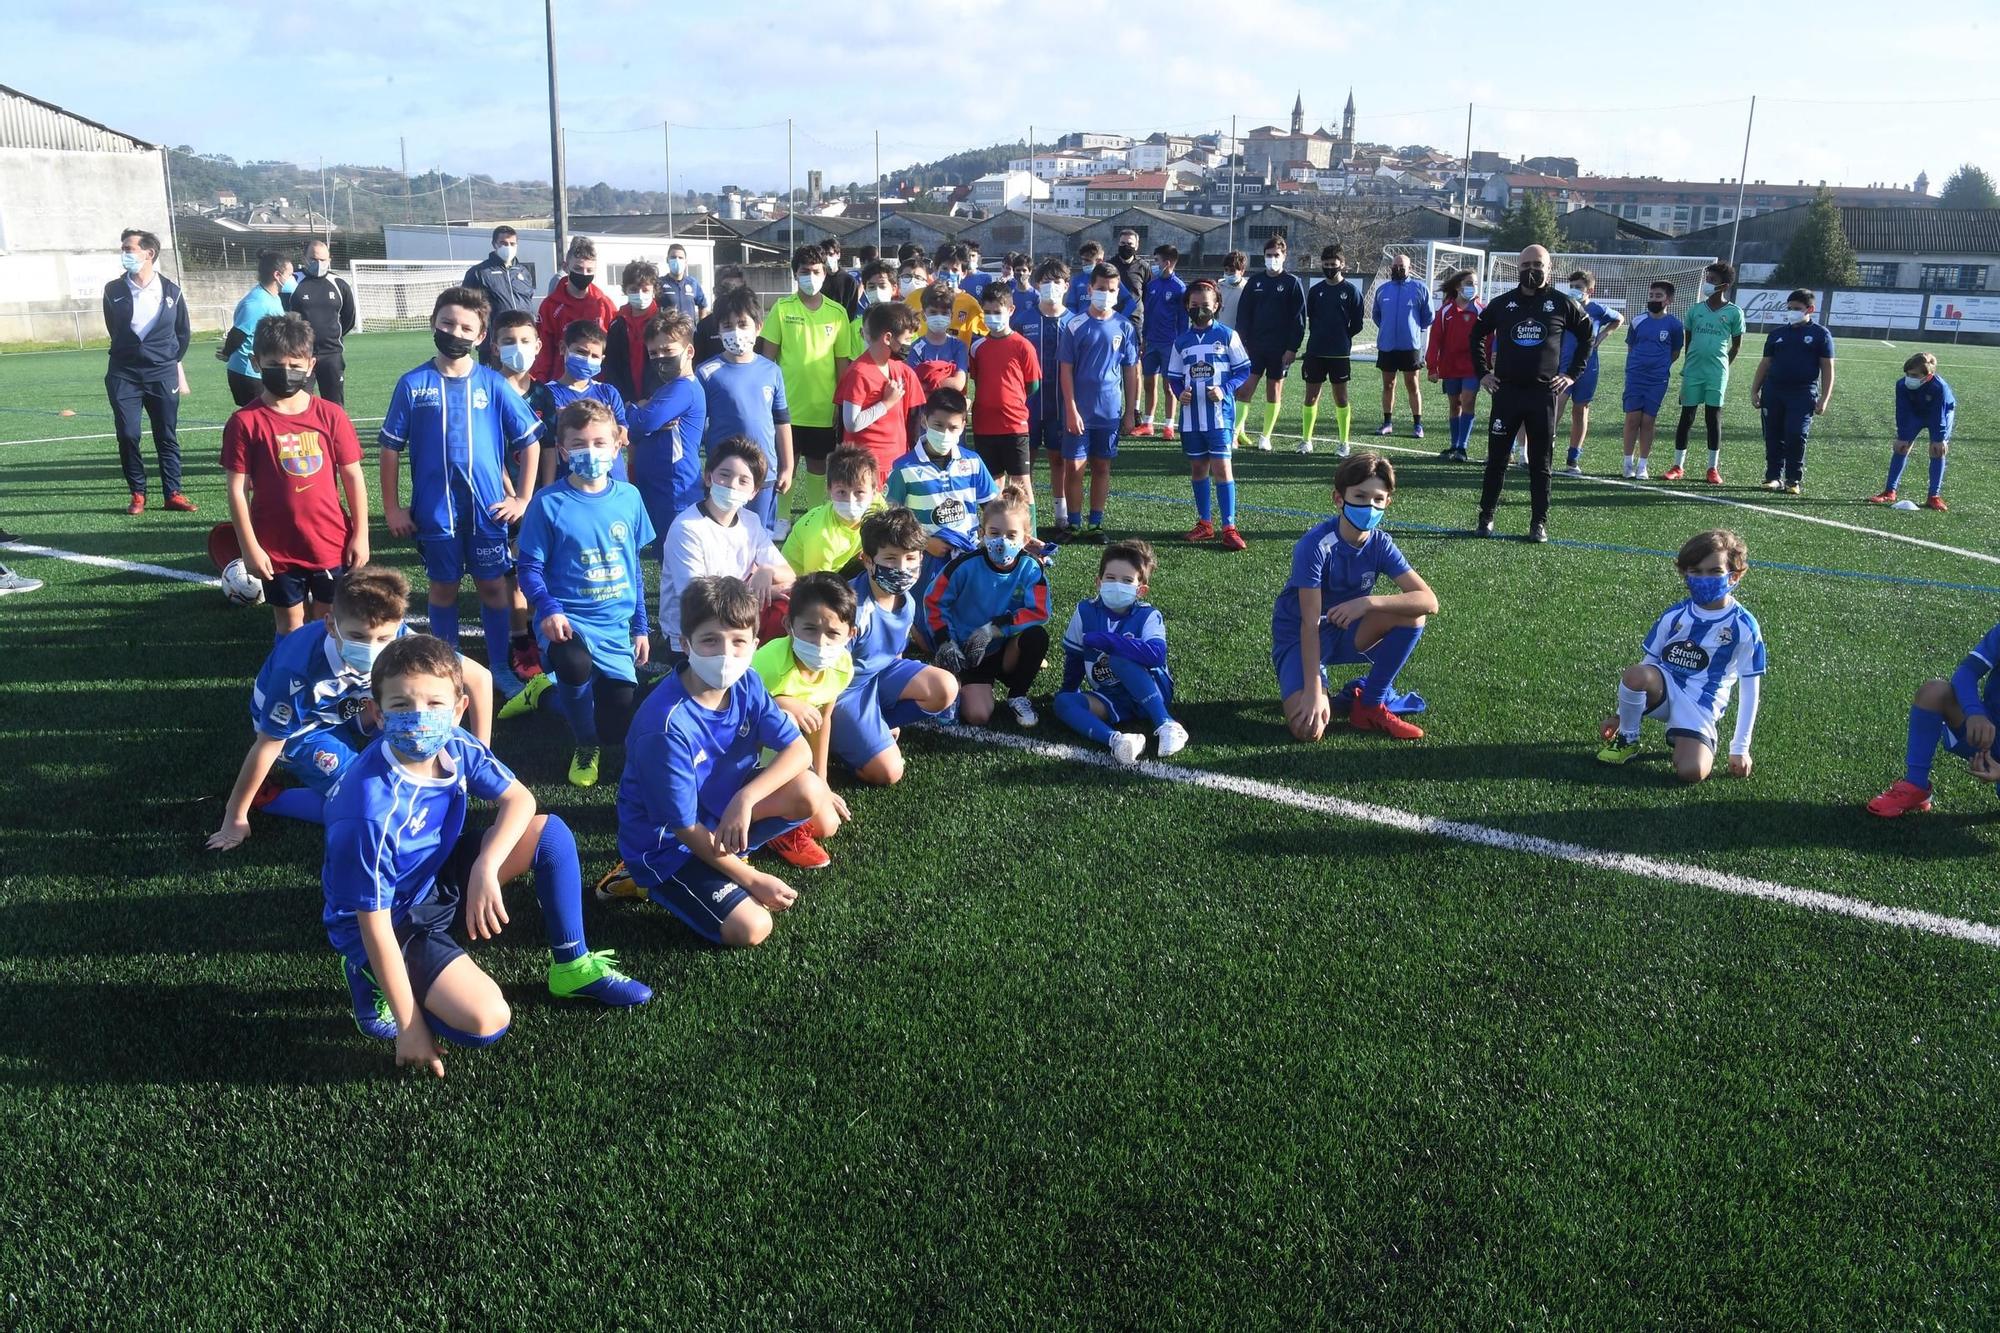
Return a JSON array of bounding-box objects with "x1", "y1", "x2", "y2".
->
[{"x1": 1472, "y1": 246, "x2": 1596, "y2": 542}]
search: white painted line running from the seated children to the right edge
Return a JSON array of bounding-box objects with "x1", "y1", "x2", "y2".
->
[{"x1": 926, "y1": 727, "x2": 2000, "y2": 949}]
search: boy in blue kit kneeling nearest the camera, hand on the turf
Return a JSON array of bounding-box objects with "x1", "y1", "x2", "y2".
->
[{"x1": 320, "y1": 634, "x2": 652, "y2": 1077}]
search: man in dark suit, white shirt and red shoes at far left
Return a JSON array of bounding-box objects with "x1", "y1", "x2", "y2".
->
[{"x1": 104, "y1": 228, "x2": 194, "y2": 514}]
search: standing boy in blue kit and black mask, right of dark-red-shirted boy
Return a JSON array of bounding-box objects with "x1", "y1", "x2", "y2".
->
[{"x1": 378, "y1": 286, "x2": 542, "y2": 699}]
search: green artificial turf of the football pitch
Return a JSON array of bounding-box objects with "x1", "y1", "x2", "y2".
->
[{"x1": 0, "y1": 324, "x2": 2000, "y2": 1329}]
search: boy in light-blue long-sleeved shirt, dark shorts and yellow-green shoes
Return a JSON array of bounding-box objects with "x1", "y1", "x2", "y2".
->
[{"x1": 500, "y1": 400, "x2": 656, "y2": 787}]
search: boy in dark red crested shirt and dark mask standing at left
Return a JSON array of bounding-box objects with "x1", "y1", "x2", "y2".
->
[{"x1": 222, "y1": 314, "x2": 368, "y2": 638}]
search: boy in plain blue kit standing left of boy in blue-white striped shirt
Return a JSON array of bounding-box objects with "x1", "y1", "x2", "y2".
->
[{"x1": 1056, "y1": 264, "x2": 1138, "y2": 542}]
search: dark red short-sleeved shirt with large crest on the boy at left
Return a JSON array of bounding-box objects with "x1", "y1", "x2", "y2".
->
[{"x1": 222, "y1": 398, "x2": 362, "y2": 572}]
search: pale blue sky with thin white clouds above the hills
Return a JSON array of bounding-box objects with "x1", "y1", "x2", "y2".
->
[{"x1": 15, "y1": 0, "x2": 2000, "y2": 192}]
